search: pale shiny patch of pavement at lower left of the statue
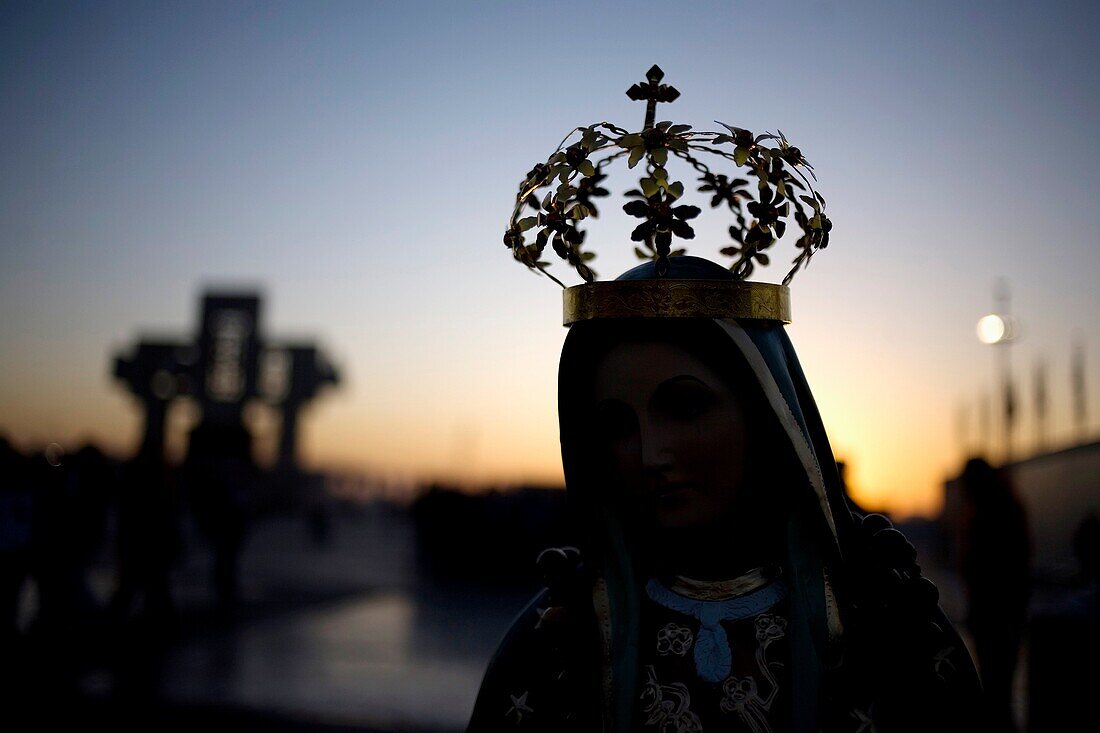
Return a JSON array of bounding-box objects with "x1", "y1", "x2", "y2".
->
[{"x1": 164, "y1": 591, "x2": 507, "y2": 730}]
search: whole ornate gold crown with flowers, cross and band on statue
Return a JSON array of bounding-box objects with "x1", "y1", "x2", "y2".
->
[{"x1": 504, "y1": 65, "x2": 833, "y2": 325}]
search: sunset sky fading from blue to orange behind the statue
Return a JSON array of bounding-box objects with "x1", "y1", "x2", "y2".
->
[{"x1": 0, "y1": 0, "x2": 1100, "y2": 514}]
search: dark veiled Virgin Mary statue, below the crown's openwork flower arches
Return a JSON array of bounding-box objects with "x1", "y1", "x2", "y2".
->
[{"x1": 468, "y1": 255, "x2": 979, "y2": 733}]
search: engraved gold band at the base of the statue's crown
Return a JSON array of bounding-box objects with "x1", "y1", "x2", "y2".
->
[{"x1": 563, "y1": 280, "x2": 791, "y2": 326}]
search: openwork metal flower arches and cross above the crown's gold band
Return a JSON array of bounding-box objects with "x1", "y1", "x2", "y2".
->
[{"x1": 504, "y1": 65, "x2": 833, "y2": 287}]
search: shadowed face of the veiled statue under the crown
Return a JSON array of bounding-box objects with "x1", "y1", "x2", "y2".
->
[{"x1": 594, "y1": 341, "x2": 746, "y2": 529}]
